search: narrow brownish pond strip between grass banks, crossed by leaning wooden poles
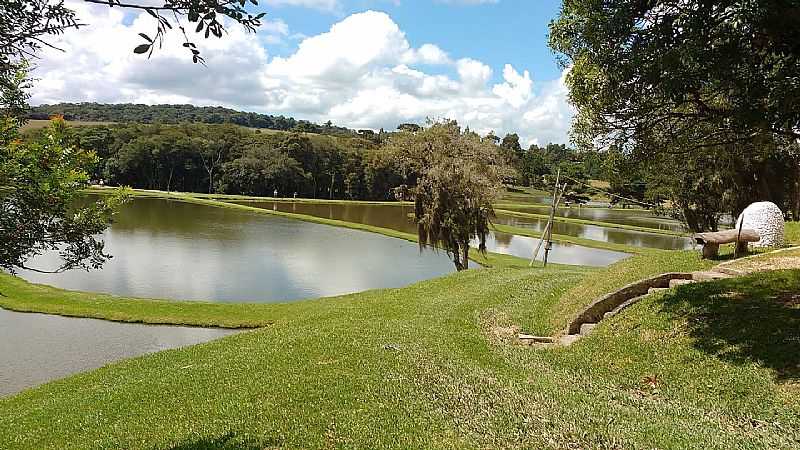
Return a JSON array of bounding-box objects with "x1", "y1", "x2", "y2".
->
[{"x1": 495, "y1": 214, "x2": 692, "y2": 250}]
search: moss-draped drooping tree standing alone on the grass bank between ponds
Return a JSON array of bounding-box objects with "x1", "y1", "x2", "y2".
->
[{"x1": 387, "y1": 121, "x2": 513, "y2": 271}]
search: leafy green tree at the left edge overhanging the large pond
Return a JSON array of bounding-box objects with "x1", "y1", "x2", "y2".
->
[{"x1": 0, "y1": 116, "x2": 126, "y2": 273}]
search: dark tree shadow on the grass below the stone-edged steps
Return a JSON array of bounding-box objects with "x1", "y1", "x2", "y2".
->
[{"x1": 662, "y1": 270, "x2": 800, "y2": 381}]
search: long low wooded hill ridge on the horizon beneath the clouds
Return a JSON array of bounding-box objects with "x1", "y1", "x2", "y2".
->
[{"x1": 28, "y1": 103, "x2": 358, "y2": 136}]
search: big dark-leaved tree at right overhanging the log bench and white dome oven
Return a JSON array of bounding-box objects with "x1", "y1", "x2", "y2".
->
[{"x1": 550, "y1": 0, "x2": 800, "y2": 231}]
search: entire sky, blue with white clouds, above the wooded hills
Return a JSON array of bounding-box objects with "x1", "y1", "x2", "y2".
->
[{"x1": 31, "y1": 0, "x2": 574, "y2": 146}]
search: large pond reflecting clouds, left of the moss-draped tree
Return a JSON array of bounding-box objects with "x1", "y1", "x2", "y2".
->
[{"x1": 21, "y1": 198, "x2": 472, "y2": 302}]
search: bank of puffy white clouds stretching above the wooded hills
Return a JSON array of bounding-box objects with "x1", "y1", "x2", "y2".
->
[{"x1": 32, "y1": 3, "x2": 573, "y2": 144}]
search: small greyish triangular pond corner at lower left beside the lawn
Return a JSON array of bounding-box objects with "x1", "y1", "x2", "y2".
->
[{"x1": 0, "y1": 309, "x2": 235, "y2": 396}]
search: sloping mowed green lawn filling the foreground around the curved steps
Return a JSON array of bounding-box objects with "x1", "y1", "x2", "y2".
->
[{"x1": 0, "y1": 252, "x2": 800, "y2": 449}]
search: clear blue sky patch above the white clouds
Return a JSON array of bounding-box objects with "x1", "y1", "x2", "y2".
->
[{"x1": 268, "y1": 0, "x2": 561, "y2": 81}]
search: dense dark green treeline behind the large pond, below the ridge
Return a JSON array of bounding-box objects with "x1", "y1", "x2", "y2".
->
[{"x1": 32, "y1": 124, "x2": 406, "y2": 200}]
